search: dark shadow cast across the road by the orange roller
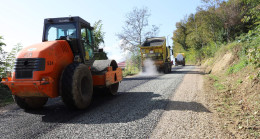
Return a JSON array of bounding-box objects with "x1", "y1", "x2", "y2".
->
[{"x1": 26, "y1": 92, "x2": 210, "y2": 124}]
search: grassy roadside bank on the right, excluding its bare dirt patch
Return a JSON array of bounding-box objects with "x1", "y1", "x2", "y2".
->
[{"x1": 205, "y1": 35, "x2": 260, "y2": 138}]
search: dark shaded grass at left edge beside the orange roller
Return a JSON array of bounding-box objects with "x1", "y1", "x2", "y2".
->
[{"x1": 0, "y1": 84, "x2": 13, "y2": 107}]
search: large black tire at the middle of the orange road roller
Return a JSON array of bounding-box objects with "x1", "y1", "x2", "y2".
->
[{"x1": 60, "y1": 63, "x2": 93, "y2": 109}]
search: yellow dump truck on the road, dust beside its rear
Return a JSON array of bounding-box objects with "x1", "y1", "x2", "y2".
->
[{"x1": 140, "y1": 37, "x2": 173, "y2": 73}]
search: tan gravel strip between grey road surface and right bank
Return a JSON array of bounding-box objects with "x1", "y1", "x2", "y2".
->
[{"x1": 151, "y1": 67, "x2": 224, "y2": 139}]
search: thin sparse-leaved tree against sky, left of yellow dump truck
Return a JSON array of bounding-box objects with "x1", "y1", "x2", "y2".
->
[{"x1": 117, "y1": 8, "x2": 159, "y2": 53}]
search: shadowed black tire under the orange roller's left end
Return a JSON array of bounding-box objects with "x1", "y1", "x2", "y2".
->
[{"x1": 13, "y1": 95, "x2": 48, "y2": 110}]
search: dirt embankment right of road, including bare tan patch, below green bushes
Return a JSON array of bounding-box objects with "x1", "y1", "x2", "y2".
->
[{"x1": 203, "y1": 52, "x2": 260, "y2": 138}]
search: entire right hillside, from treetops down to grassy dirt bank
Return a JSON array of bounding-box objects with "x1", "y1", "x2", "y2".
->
[{"x1": 173, "y1": 0, "x2": 260, "y2": 138}]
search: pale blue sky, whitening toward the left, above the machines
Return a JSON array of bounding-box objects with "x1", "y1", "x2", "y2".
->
[{"x1": 0, "y1": 0, "x2": 201, "y2": 62}]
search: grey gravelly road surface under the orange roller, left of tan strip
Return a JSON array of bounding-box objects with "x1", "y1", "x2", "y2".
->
[{"x1": 0, "y1": 66, "x2": 194, "y2": 139}]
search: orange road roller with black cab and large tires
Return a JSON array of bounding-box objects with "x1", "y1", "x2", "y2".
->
[{"x1": 2, "y1": 17, "x2": 123, "y2": 109}]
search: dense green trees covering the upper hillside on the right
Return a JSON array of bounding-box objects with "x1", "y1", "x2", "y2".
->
[{"x1": 172, "y1": 0, "x2": 260, "y2": 67}]
